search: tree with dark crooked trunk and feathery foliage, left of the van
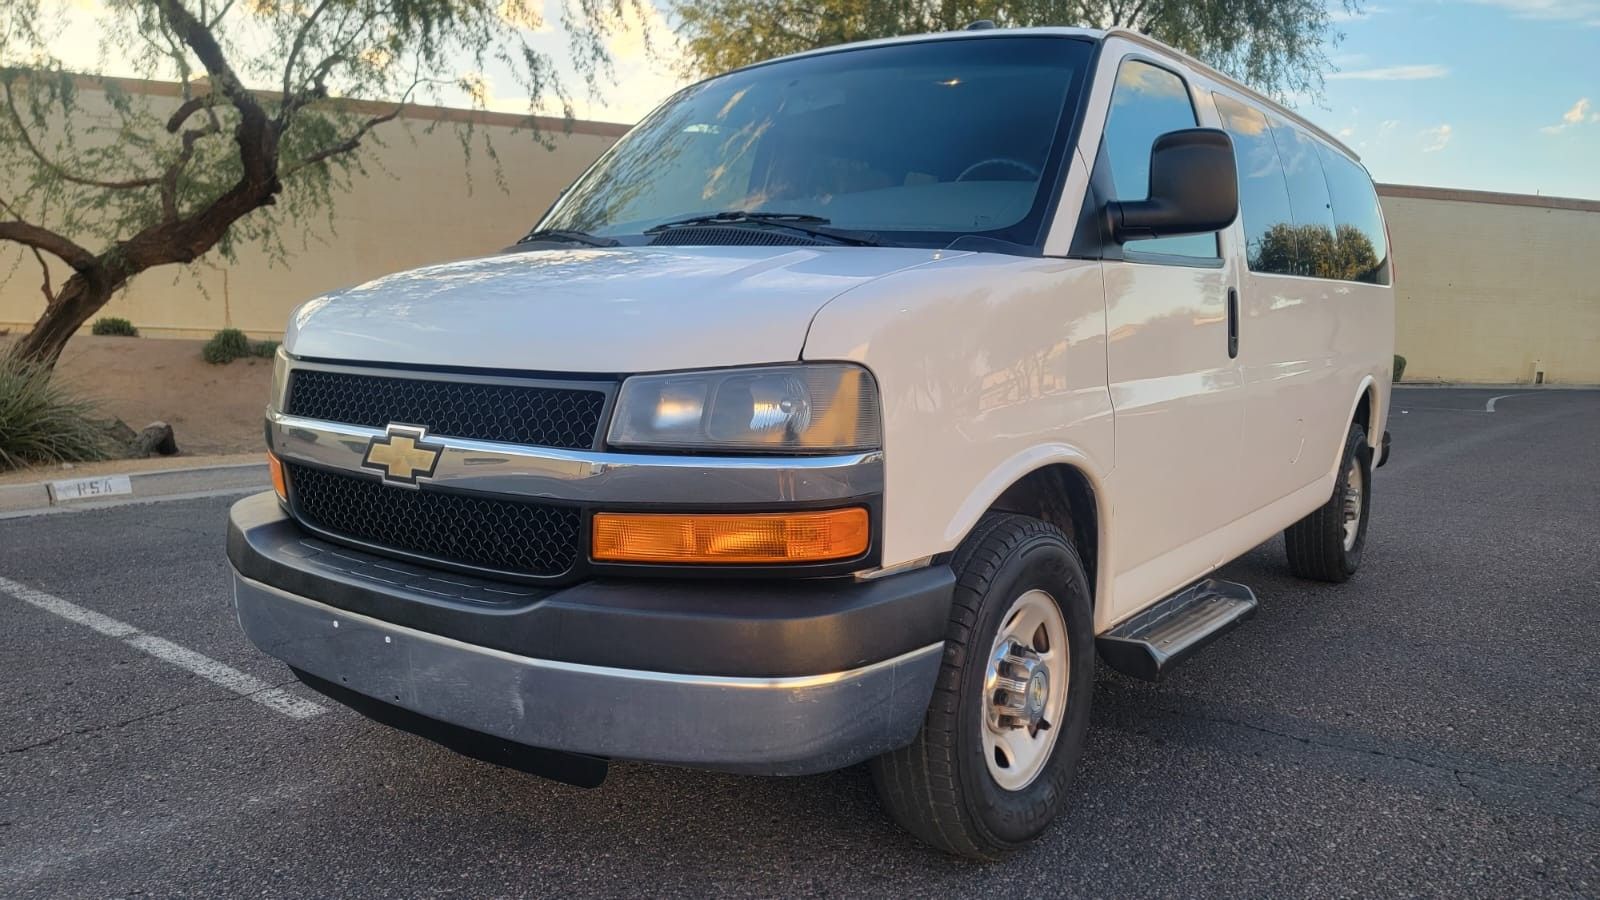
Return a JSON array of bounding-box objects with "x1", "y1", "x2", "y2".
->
[{"x1": 0, "y1": 0, "x2": 645, "y2": 365}]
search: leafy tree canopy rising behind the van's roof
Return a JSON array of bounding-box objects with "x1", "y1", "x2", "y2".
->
[{"x1": 674, "y1": 0, "x2": 1358, "y2": 96}]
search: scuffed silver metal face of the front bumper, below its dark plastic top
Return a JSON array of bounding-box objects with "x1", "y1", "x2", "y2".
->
[{"x1": 234, "y1": 572, "x2": 942, "y2": 775}]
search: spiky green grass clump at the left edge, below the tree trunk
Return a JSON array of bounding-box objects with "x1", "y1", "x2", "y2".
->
[{"x1": 0, "y1": 354, "x2": 110, "y2": 471}]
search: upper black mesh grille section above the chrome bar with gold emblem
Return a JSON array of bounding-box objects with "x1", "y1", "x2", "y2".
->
[{"x1": 285, "y1": 368, "x2": 605, "y2": 450}]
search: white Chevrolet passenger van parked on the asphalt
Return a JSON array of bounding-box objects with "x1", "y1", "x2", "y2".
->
[{"x1": 229, "y1": 29, "x2": 1394, "y2": 857}]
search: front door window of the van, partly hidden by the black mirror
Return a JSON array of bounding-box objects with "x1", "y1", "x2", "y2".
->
[{"x1": 1101, "y1": 59, "x2": 1218, "y2": 259}]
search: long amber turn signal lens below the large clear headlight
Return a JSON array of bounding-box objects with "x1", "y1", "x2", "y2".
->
[{"x1": 590, "y1": 508, "x2": 870, "y2": 565}]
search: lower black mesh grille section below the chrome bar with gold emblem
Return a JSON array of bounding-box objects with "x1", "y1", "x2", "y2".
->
[{"x1": 285, "y1": 464, "x2": 581, "y2": 578}]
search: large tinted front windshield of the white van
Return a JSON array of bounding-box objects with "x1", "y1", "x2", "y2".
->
[{"x1": 538, "y1": 35, "x2": 1091, "y2": 247}]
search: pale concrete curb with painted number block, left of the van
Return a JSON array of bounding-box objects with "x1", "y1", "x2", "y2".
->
[{"x1": 0, "y1": 463, "x2": 272, "y2": 514}]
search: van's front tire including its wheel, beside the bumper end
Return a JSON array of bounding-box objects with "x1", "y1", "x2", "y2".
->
[{"x1": 872, "y1": 514, "x2": 1094, "y2": 858}]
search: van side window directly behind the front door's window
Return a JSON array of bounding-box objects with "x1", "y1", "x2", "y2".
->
[{"x1": 1211, "y1": 94, "x2": 1296, "y2": 275}]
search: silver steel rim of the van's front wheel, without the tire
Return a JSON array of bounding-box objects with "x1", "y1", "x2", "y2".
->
[{"x1": 984, "y1": 589, "x2": 1070, "y2": 791}]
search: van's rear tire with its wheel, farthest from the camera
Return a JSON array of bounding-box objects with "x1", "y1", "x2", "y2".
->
[{"x1": 1283, "y1": 424, "x2": 1373, "y2": 583}]
